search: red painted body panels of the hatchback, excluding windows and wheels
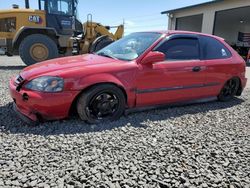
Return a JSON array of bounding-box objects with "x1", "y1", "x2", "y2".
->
[{"x1": 10, "y1": 31, "x2": 247, "y2": 121}]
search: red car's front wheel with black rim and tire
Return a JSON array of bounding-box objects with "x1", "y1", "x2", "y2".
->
[{"x1": 77, "y1": 84, "x2": 126, "y2": 124}]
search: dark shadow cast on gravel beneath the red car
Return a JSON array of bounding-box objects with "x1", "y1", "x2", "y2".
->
[{"x1": 0, "y1": 98, "x2": 244, "y2": 136}]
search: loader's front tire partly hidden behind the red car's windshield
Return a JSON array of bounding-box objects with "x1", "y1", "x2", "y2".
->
[{"x1": 90, "y1": 36, "x2": 114, "y2": 53}]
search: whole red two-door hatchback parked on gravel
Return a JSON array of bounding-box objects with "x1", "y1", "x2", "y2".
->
[{"x1": 9, "y1": 31, "x2": 247, "y2": 123}]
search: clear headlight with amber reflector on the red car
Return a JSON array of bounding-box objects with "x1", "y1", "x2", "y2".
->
[{"x1": 25, "y1": 76, "x2": 64, "y2": 92}]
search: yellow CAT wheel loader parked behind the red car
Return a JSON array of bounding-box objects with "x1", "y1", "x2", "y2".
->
[{"x1": 0, "y1": 0, "x2": 124, "y2": 65}]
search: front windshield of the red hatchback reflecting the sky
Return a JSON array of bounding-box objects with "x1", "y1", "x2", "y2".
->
[{"x1": 96, "y1": 33, "x2": 161, "y2": 61}]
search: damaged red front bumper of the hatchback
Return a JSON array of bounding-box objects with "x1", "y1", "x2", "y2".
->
[{"x1": 9, "y1": 79, "x2": 79, "y2": 124}]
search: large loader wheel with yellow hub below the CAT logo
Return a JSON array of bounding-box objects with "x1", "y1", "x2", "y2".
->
[{"x1": 19, "y1": 34, "x2": 58, "y2": 65}]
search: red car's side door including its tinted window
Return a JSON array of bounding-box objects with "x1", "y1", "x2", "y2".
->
[{"x1": 136, "y1": 35, "x2": 205, "y2": 106}]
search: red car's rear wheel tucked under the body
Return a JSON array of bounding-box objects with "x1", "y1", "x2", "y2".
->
[{"x1": 218, "y1": 78, "x2": 240, "y2": 102}]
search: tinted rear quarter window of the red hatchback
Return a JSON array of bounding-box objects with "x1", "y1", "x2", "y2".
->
[{"x1": 201, "y1": 36, "x2": 232, "y2": 60}]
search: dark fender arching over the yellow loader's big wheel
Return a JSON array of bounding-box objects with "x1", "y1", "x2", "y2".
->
[{"x1": 12, "y1": 27, "x2": 58, "y2": 51}]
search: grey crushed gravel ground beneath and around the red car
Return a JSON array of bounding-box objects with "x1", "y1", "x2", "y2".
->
[{"x1": 0, "y1": 57, "x2": 250, "y2": 188}]
